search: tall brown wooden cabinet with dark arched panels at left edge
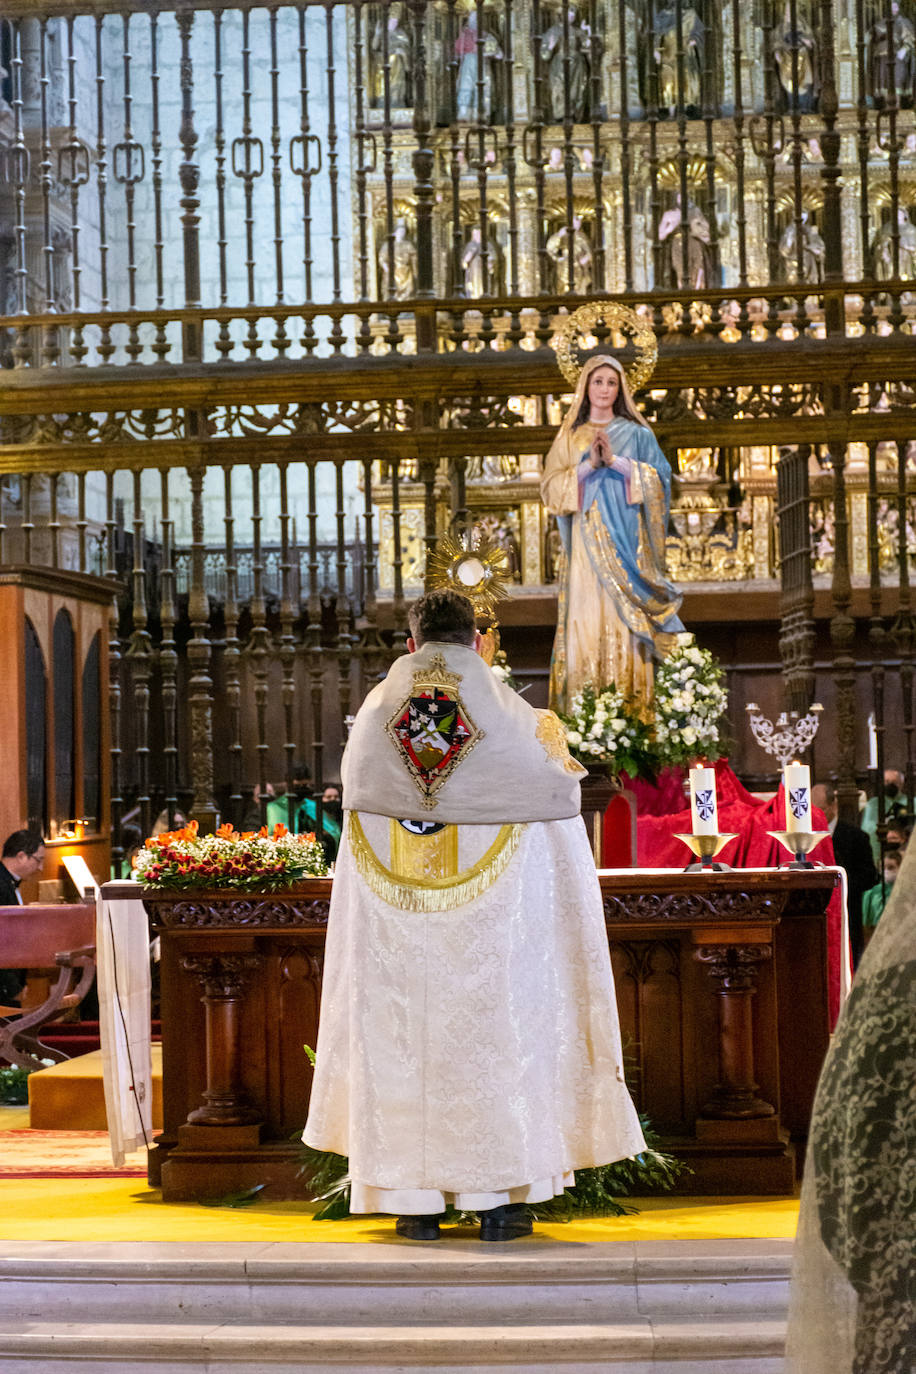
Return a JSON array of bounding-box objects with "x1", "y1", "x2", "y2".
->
[{"x1": 0, "y1": 565, "x2": 117, "y2": 901}]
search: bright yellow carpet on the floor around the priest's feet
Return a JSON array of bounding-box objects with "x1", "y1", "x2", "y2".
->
[{"x1": 0, "y1": 1179, "x2": 798, "y2": 1243}]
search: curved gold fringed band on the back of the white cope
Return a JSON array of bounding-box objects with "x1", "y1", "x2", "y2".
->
[{"x1": 347, "y1": 811, "x2": 525, "y2": 912}]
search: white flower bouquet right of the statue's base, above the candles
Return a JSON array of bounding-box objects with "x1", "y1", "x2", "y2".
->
[{"x1": 652, "y1": 633, "x2": 728, "y2": 767}]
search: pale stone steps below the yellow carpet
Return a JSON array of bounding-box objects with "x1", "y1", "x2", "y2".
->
[{"x1": 0, "y1": 1238, "x2": 791, "y2": 1374}]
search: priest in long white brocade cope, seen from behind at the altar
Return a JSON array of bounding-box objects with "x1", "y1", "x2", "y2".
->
[{"x1": 304, "y1": 591, "x2": 645, "y2": 1241}]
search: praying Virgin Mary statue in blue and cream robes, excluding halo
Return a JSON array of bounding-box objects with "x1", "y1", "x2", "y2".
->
[{"x1": 541, "y1": 356, "x2": 684, "y2": 719}]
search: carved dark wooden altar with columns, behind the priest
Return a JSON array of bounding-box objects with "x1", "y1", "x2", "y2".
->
[{"x1": 144, "y1": 870, "x2": 836, "y2": 1198}]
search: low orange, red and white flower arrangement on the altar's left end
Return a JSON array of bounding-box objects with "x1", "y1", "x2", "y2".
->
[{"x1": 135, "y1": 820, "x2": 328, "y2": 892}]
